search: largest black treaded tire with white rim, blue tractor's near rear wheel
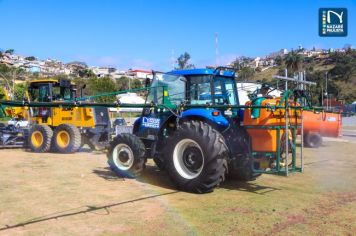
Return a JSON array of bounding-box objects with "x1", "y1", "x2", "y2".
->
[{"x1": 164, "y1": 121, "x2": 228, "y2": 193}]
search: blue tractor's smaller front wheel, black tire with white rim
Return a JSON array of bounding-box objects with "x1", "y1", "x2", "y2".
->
[{"x1": 107, "y1": 133, "x2": 146, "y2": 178}]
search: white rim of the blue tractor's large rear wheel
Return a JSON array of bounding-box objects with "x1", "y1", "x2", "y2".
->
[{"x1": 173, "y1": 139, "x2": 204, "y2": 179}]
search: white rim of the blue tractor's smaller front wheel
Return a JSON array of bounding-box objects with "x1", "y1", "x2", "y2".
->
[{"x1": 113, "y1": 143, "x2": 134, "y2": 170}]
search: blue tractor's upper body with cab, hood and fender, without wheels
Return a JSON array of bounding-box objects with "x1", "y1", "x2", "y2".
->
[{"x1": 134, "y1": 69, "x2": 239, "y2": 140}]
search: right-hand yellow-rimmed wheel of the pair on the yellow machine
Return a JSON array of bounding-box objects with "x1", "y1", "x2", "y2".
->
[{"x1": 53, "y1": 124, "x2": 82, "y2": 153}]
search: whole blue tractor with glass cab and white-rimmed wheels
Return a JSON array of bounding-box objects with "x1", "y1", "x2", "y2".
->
[{"x1": 108, "y1": 68, "x2": 259, "y2": 193}]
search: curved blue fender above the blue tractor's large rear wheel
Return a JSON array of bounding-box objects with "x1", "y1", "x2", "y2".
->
[{"x1": 180, "y1": 108, "x2": 229, "y2": 127}]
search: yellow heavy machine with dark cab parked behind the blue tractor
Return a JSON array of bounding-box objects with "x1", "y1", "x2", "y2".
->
[{"x1": 26, "y1": 79, "x2": 110, "y2": 153}]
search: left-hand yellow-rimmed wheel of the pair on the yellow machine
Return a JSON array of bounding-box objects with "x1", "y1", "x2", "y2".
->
[{"x1": 28, "y1": 124, "x2": 53, "y2": 153}]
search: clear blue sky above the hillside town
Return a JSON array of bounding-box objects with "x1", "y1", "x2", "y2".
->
[{"x1": 0, "y1": 0, "x2": 356, "y2": 70}]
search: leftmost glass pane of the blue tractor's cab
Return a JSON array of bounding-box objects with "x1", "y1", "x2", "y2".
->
[{"x1": 146, "y1": 74, "x2": 185, "y2": 105}]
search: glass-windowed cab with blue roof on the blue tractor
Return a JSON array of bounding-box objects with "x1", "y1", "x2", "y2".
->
[{"x1": 147, "y1": 69, "x2": 239, "y2": 116}]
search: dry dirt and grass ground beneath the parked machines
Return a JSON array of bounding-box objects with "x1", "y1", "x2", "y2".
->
[{"x1": 0, "y1": 139, "x2": 356, "y2": 236}]
